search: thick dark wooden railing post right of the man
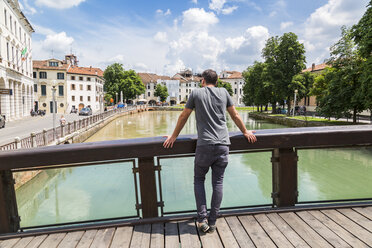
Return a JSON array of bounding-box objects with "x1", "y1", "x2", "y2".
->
[{"x1": 271, "y1": 148, "x2": 298, "y2": 207}]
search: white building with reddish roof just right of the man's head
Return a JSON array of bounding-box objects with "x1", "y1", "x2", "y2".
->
[{"x1": 220, "y1": 71, "x2": 245, "y2": 106}]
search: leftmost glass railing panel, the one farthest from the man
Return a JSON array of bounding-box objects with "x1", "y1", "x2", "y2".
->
[{"x1": 14, "y1": 161, "x2": 137, "y2": 228}]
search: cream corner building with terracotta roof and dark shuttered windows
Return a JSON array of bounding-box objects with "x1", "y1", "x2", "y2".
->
[{"x1": 33, "y1": 55, "x2": 104, "y2": 114}]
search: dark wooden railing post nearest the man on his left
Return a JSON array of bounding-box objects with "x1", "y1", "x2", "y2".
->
[{"x1": 138, "y1": 157, "x2": 158, "y2": 218}]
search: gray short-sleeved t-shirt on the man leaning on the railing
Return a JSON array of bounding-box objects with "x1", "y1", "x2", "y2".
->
[{"x1": 185, "y1": 87, "x2": 234, "y2": 146}]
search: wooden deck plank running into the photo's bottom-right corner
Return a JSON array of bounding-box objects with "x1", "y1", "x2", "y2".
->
[{"x1": 322, "y1": 210, "x2": 372, "y2": 246}]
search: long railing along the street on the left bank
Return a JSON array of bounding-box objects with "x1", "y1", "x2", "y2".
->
[{"x1": 0, "y1": 105, "x2": 146, "y2": 151}]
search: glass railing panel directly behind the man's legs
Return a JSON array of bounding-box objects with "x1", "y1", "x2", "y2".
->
[{"x1": 160, "y1": 152, "x2": 272, "y2": 214}]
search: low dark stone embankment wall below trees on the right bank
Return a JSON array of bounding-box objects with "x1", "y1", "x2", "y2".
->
[{"x1": 249, "y1": 113, "x2": 332, "y2": 127}]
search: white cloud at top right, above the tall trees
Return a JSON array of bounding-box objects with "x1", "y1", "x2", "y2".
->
[{"x1": 303, "y1": 0, "x2": 368, "y2": 63}]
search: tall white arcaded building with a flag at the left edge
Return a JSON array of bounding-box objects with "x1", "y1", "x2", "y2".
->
[{"x1": 0, "y1": 0, "x2": 34, "y2": 121}]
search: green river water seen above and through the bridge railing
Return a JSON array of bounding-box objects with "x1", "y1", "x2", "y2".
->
[{"x1": 17, "y1": 112, "x2": 372, "y2": 226}]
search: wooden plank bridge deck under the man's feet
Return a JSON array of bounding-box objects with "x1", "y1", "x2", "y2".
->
[{"x1": 0, "y1": 207, "x2": 372, "y2": 248}]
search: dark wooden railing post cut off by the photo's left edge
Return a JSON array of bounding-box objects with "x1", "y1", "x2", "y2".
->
[{"x1": 0, "y1": 170, "x2": 20, "y2": 234}]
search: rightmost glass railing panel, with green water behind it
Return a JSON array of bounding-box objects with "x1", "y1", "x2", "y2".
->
[{"x1": 298, "y1": 147, "x2": 372, "y2": 202}]
